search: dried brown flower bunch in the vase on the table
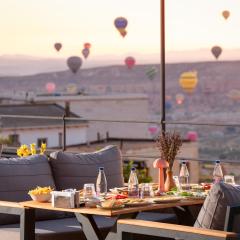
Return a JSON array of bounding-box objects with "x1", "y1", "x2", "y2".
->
[{"x1": 156, "y1": 131, "x2": 182, "y2": 171}]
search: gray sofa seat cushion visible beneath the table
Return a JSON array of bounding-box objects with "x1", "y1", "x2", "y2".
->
[{"x1": 0, "y1": 216, "x2": 116, "y2": 240}]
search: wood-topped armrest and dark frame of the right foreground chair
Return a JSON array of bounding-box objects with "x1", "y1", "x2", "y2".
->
[{"x1": 117, "y1": 206, "x2": 240, "y2": 240}]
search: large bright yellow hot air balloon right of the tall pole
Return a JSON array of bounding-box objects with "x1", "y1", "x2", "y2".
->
[{"x1": 179, "y1": 72, "x2": 198, "y2": 93}]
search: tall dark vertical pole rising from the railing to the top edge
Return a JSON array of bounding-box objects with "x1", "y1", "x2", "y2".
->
[{"x1": 160, "y1": 0, "x2": 166, "y2": 132}]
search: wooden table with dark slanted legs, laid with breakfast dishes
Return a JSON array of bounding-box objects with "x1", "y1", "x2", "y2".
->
[{"x1": 20, "y1": 200, "x2": 204, "y2": 240}]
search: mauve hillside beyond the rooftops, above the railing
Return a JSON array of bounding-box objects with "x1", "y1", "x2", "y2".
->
[{"x1": 0, "y1": 61, "x2": 240, "y2": 120}]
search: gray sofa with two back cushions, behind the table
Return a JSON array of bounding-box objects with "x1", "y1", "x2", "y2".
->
[{"x1": 0, "y1": 146, "x2": 175, "y2": 240}]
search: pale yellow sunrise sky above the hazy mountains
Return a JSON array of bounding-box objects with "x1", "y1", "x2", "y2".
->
[{"x1": 0, "y1": 0, "x2": 240, "y2": 58}]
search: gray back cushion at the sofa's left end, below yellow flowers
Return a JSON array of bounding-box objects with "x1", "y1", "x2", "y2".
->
[{"x1": 0, "y1": 155, "x2": 64, "y2": 224}]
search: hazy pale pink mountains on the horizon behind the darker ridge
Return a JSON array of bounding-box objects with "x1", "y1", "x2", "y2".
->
[{"x1": 0, "y1": 48, "x2": 240, "y2": 76}]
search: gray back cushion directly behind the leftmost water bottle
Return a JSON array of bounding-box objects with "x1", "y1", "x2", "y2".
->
[{"x1": 50, "y1": 146, "x2": 123, "y2": 190}]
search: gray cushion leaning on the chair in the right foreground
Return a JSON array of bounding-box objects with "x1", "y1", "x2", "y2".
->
[{"x1": 194, "y1": 183, "x2": 240, "y2": 232}]
